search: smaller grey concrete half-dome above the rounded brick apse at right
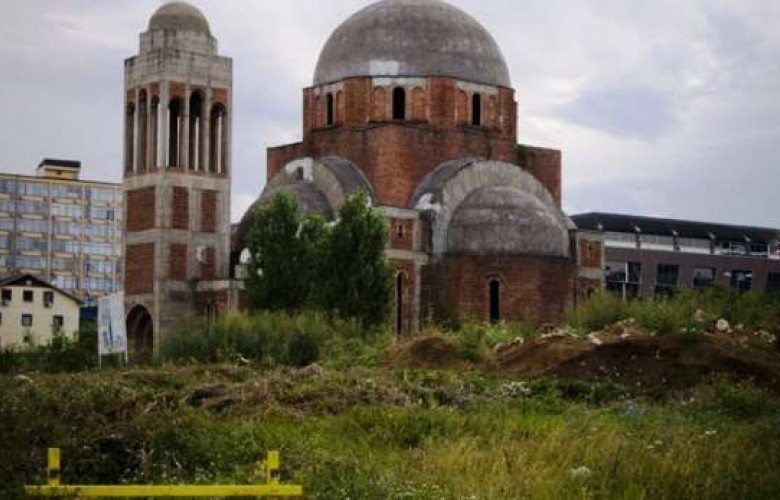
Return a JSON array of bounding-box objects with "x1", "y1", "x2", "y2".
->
[{"x1": 448, "y1": 186, "x2": 569, "y2": 257}]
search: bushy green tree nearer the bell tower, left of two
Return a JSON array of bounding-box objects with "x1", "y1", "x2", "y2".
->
[{"x1": 246, "y1": 191, "x2": 328, "y2": 311}]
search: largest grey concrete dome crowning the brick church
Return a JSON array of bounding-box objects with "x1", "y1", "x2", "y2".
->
[{"x1": 314, "y1": 0, "x2": 511, "y2": 87}]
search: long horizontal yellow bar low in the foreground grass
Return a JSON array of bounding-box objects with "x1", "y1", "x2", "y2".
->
[{"x1": 24, "y1": 484, "x2": 303, "y2": 498}]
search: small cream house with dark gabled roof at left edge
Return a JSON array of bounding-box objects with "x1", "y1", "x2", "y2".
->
[{"x1": 0, "y1": 274, "x2": 81, "y2": 349}]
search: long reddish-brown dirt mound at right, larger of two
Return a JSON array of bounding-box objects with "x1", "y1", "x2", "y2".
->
[{"x1": 496, "y1": 335, "x2": 780, "y2": 394}]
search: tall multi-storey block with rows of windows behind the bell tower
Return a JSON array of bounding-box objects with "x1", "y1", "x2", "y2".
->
[{"x1": 0, "y1": 158, "x2": 122, "y2": 303}]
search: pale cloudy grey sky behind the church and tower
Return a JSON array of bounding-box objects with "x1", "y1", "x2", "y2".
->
[{"x1": 0, "y1": 0, "x2": 780, "y2": 228}]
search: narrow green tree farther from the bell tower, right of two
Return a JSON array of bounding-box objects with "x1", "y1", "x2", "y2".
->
[{"x1": 323, "y1": 192, "x2": 393, "y2": 328}]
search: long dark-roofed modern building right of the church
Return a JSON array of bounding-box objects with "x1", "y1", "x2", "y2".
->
[{"x1": 571, "y1": 212, "x2": 780, "y2": 298}]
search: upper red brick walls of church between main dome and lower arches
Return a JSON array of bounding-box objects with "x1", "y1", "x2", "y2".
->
[{"x1": 267, "y1": 78, "x2": 561, "y2": 207}]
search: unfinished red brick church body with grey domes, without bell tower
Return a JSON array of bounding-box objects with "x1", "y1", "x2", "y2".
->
[{"x1": 234, "y1": 0, "x2": 603, "y2": 331}]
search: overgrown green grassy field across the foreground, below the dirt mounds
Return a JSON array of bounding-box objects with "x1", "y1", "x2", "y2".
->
[{"x1": 0, "y1": 365, "x2": 780, "y2": 499}]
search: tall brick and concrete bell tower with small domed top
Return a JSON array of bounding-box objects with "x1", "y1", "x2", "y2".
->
[{"x1": 123, "y1": 2, "x2": 233, "y2": 358}]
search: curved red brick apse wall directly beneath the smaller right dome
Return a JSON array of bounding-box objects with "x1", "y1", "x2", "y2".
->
[{"x1": 423, "y1": 255, "x2": 575, "y2": 325}]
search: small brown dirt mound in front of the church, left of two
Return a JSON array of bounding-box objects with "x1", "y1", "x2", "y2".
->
[{"x1": 387, "y1": 335, "x2": 473, "y2": 369}]
